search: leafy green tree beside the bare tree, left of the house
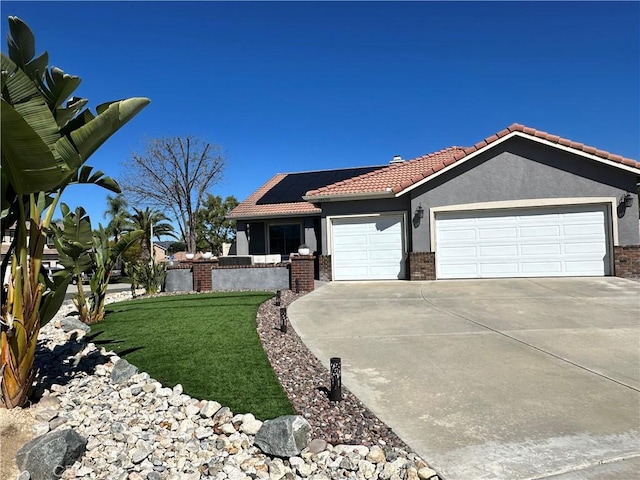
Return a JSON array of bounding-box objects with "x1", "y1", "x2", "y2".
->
[{"x1": 196, "y1": 193, "x2": 238, "y2": 256}]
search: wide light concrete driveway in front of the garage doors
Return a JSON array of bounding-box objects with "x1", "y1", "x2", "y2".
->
[{"x1": 288, "y1": 277, "x2": 640, "y2": 480}]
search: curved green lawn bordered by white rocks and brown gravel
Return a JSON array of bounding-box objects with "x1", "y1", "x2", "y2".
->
[{"x1": 90, "y1": 292, "x2": 294, "y2": 420}]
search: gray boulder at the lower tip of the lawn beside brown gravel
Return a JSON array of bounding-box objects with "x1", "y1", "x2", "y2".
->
[{"x1": 253, "y1": 415, "x2": 311, "y2": 457}]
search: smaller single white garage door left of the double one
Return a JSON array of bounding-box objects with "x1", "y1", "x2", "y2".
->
[{"x1": 331, "y1": 215, "x2": 404, "y2": 280}]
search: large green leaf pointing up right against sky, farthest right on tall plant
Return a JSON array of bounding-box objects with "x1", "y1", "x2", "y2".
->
[{"x1": 70, "y1": 97, "x2": 151, "y2": 160}]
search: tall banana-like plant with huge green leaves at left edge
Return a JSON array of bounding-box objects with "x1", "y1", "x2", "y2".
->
[{"x1": 0, "y1": 17, "x2": 149, "y2": 408}]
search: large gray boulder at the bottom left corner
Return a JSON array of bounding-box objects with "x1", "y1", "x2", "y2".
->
[{"x1": 16, "y1": 428, "x2": 87, "y2": 480}]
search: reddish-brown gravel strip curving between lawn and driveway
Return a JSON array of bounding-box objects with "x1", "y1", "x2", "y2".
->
[{"x1": 257, "y1": 290, "x2": 410, "y2": 451}]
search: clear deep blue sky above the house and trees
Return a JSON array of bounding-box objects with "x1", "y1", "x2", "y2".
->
[{"x1": 1, "y1": 1, "x2": 640, "y2": 232}]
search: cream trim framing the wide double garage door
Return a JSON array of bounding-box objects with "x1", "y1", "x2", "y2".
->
[{"x1": 429, "y1": 197, "x2": 619, "y2": 248}]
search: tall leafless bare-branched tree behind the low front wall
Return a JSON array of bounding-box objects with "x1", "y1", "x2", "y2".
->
[{"x1": 121, "y1": 136, "x2": 225, "y2": 252}]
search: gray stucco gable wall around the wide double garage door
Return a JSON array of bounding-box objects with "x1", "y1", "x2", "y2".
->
[{"x1": 410, "y1": 138, "x2": 640, "y2": 252}]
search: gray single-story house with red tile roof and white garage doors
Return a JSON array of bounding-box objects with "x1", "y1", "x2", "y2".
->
[{"x1": 229, "y1": 124, "x2": 640, "y2": 280}]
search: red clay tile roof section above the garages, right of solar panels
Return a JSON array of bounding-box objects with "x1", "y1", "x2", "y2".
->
[{"x1": 305, "y1": 123, "x2": 640, "y2": 201}]
